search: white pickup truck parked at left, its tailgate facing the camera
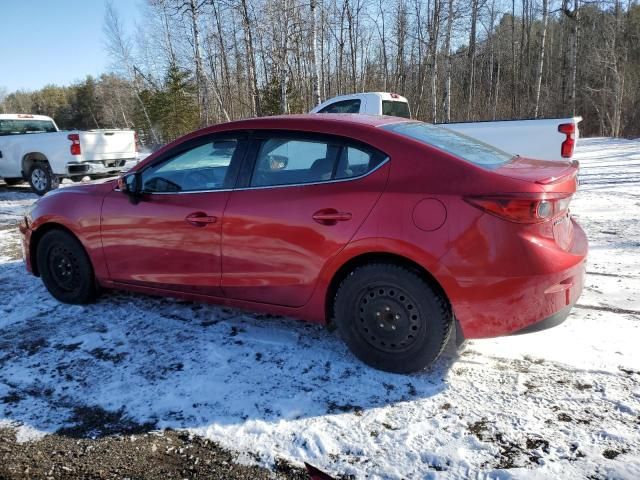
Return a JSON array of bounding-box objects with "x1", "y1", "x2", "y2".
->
[{"x1": 0, "y1": 114, "x2": 137, "y2": 195}]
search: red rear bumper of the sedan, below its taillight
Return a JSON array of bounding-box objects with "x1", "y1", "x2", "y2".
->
[{"x1": 451, "y1": 219, "x2": 588, "y2": 339}]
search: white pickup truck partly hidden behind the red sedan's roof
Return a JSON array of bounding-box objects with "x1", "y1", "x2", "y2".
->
[{"x1": 310, "y1": 92, "x2": 582, "y2": 160}]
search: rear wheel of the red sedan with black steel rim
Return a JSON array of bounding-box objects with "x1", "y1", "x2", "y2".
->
[{"x1": 334, "y1": 263, "x2": 454, "y2": 373}]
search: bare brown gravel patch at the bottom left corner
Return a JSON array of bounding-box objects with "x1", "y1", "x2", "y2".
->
[{"x1": 0, "y1": 428, "x2": 309, "y2": 480}]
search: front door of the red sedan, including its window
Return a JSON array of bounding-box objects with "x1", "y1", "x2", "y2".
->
[{"x1": 101, "y1": 136, "x2": 246, "y2": 296}]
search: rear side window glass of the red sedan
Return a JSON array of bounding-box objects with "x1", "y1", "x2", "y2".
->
[{"x1": 250, "y1": 138, "x2": 386, "y2": 187}]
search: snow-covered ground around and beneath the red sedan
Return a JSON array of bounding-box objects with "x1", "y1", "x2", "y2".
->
[{"x1": 0, "y1": 139, "x2": 640, "y2": 479}]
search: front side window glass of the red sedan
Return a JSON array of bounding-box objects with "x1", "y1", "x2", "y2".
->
[{"x1": 142, "y1": 140, "x2": 238, "y2": 193}]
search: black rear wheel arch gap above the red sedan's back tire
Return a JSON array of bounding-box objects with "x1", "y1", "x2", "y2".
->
[{"x1": 325, "y1": 252, "x2": 453, "y2": 327}]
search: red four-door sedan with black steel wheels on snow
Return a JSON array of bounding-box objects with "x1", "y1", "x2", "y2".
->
[{"x1": 21, "y1": 114, "x2": 587, "y2": 372}]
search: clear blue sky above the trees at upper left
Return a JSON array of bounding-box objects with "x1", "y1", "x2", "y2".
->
[{"x1": 0, "y1": 0, "x2": 142, "y2": 92}]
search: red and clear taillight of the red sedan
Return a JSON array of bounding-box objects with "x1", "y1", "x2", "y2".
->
[{"x1": 465, "y1": 194, "x2": 571, "y2": 223}]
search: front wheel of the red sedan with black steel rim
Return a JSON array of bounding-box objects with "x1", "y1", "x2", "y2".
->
[{"x1": 36, "y1": 230, "x2": 96, "y2": 304}]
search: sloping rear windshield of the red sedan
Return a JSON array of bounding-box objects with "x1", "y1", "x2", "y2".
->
[{"x1": 381, "y1": 122, "x2": 514, "y2": 170}]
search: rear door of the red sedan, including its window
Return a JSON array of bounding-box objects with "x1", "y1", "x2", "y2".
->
[{"x1": 222, "y1": 132, "x2": 389, "y2": 307}]
